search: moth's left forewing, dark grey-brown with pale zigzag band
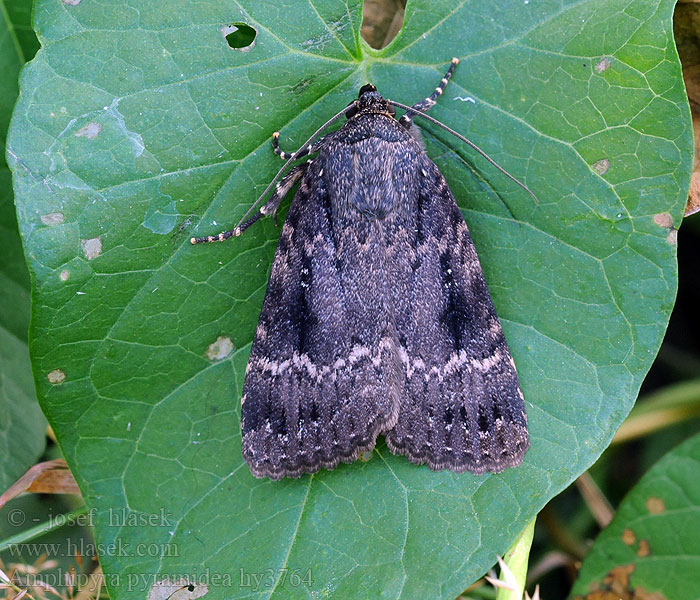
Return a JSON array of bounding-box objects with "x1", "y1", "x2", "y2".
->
[{"x1": 241, "y1": 161, "x2": 401, "y2": 479}]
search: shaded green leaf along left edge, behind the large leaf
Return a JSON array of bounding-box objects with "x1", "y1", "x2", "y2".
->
[{"x1": 0, "y1": 0, "x2": 46, "y2": 491}]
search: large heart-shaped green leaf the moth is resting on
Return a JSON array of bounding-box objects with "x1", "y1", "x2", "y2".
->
[{"x1": 6, "y1": 0, "x2": 692, "y2": 599}]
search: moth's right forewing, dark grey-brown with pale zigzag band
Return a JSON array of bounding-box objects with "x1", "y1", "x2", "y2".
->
[{"x1": 386, "y1": 158, "x2": 529, "y2": 473}]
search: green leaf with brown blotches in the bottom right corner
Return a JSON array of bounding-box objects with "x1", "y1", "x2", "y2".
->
[{"x1": 572, "y1": 435, "x2": 700, "y2": 600}]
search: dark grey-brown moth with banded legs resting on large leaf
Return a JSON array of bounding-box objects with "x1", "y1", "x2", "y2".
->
[{"x1": 191, "y1": 58, "x2": 532, "y2": 479}]
